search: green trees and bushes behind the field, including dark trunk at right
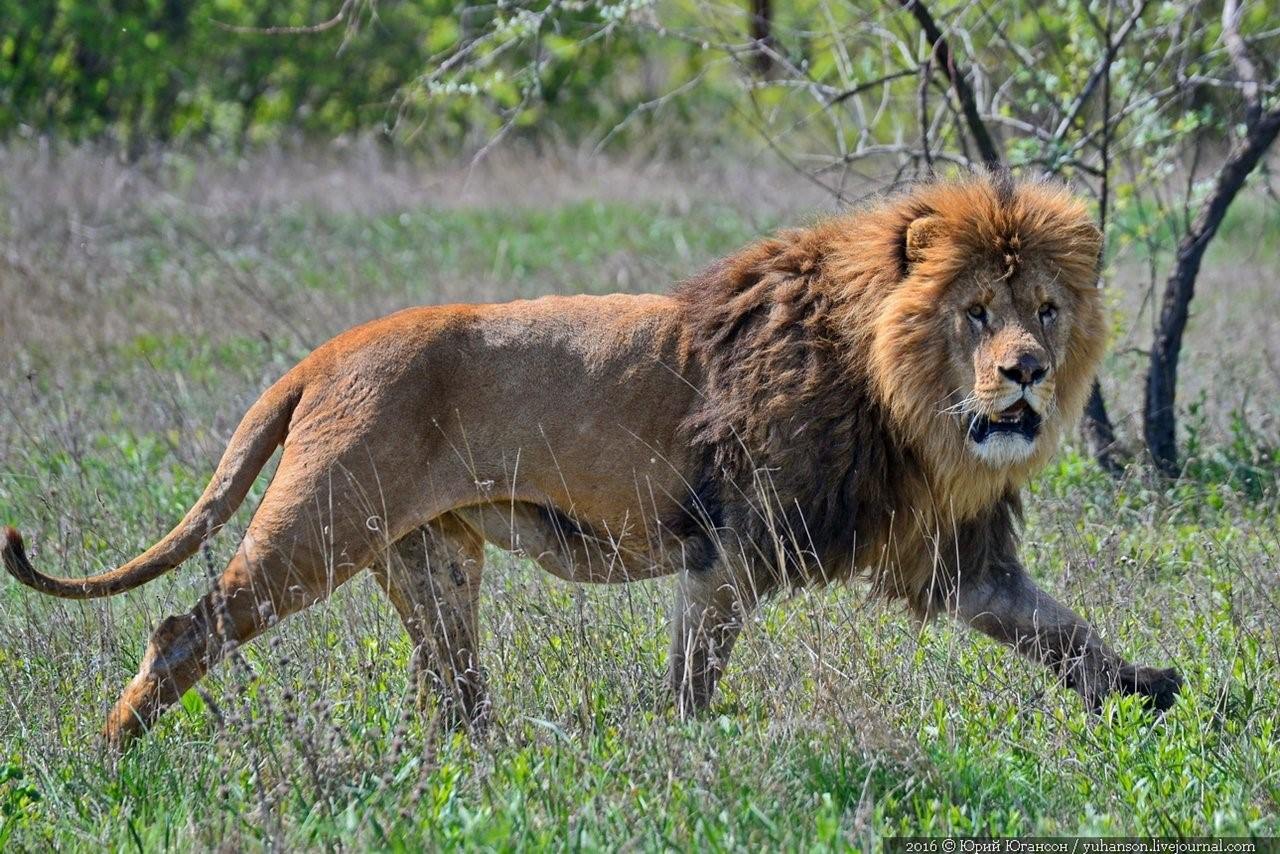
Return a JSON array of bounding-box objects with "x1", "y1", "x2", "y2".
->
[{"x1": 10, "y1": 0, "x2": 1280, "y2": 478}]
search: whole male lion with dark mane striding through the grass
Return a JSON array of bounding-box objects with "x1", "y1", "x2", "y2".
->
[{"x1": 4, "y1": 175, "x2": 1180, "y2": 744}]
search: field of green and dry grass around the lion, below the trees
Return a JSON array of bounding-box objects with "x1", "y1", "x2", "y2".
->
[{"x1": 0, "y1": 151, "x2": 1280, "y2": 850}]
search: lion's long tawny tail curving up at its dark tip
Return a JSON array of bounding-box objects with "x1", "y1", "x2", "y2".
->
[{"x1": 0, "y1": 370, "x2": 302, "y2": 599}]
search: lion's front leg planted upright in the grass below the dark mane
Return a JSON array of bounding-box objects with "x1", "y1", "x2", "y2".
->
[{"x1": 668, "y1": 563, "x2": 762, "y2": 717}]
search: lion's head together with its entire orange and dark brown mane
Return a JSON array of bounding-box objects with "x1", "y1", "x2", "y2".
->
[{"x1": 677, "y1": 174, "x2": 1106, "y2": 568}]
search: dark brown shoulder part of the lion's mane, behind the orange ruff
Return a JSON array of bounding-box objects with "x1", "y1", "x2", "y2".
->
[{"x1": 676, "y1": 230, "x2": 910, "y2": 583}]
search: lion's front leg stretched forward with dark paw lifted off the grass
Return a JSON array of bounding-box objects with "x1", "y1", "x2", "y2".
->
[{"x1": 951, "y1": 563, "x2": 1181, "y2": 712}]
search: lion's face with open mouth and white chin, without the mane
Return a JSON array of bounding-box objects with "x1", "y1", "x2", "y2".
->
[{"x1": 941, "y1": 262, "x2": 1079, "y2": 466}]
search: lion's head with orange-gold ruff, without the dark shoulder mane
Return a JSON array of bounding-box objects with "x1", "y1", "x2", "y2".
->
[{"x1": 844, "y1": 177, "x2": 1106, "y2": 494}]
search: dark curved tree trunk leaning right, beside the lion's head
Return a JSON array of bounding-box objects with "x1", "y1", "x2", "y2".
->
[{"x1": 1143, "y1": 109, "x2": 1280, "y2": 478}]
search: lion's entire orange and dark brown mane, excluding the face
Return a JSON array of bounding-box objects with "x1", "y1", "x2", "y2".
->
[{"x1": 676, "y1": 175, "x2": 1105, "y2": 597}]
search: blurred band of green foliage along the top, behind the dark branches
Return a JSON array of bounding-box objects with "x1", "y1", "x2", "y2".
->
[{"x1": 0, "y1": 0, "x2": 1277, "y2": 162}]
